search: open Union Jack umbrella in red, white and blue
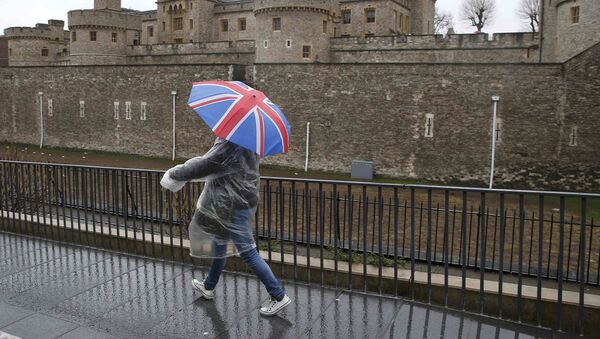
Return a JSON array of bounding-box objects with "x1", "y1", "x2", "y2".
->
[{"x1": 188, "y1": 81, "x2": 291, "y2": 157}]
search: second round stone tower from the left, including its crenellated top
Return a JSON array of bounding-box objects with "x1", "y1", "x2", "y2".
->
[{"x1": 69, "y1": 9, "x2": 142, "y2": 65}]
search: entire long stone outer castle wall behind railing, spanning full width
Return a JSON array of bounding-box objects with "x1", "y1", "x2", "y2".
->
[{"x1": 0, "y1": 57, "x2": 600, "y2": 191}]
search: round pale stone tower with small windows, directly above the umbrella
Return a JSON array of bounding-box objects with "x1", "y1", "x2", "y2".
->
[{"x1": 254, "y1": 0, "x2": 335, "y2": 63}]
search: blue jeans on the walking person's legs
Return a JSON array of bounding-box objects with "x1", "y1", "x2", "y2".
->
[{"x1": 204, "y1": 209, "x2": 285, "y2": 300}]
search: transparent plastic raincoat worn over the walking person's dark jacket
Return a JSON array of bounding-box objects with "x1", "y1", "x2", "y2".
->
[{"x1": 161, "y1": 138, "x2": 260, "y2": 258}]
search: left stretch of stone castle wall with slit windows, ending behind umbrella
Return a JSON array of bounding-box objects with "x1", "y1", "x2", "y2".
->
[{"x1": 0, "y1": 65, "x2": 233, "y2": 157}]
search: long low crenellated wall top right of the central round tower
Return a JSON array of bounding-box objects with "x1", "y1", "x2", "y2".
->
[{"x1": 331, "y1": 33, "x2": 539, "y2": 51}]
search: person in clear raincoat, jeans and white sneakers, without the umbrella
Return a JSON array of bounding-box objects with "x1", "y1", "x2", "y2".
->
[{"x1": 161, "y1": 138, "x2": 291, "y2": 316}]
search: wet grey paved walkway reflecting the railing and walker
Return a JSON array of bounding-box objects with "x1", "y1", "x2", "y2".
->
[{"x1": 0, "y1": 232, "x2": 564, "y2": 338}]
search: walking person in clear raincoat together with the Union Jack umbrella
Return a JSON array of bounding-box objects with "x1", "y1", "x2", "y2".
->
[{"x1": 161, "y1": 81, "x2": 291, "y2": 316}]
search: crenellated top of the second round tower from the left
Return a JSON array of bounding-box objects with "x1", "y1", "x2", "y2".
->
[{"x1": 68, "y1": 9, "x2": 143, "y2": 30}]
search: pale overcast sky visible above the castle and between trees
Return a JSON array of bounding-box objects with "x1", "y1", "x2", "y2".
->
[{"x1": 0, "y1": 0, "x2": 526, "y2": 34}]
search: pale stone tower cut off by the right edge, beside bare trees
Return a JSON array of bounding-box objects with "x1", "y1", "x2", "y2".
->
[{"x1": 541, "y1": 0, "x2": 600, "y2": 62}]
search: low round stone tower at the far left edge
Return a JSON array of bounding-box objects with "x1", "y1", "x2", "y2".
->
[{"x1": 4, "y1": 20, "x2": 67, "y2": 66}]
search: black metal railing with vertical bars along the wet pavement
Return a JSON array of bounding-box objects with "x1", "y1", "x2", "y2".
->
[{"x1": 0, "y1": 161, "x2": 600, "y2": 331}]
